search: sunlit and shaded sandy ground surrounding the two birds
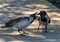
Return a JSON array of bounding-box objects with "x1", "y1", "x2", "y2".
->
[{"x1": 0, "y1": 0, "x2": 60, "y2": 42}]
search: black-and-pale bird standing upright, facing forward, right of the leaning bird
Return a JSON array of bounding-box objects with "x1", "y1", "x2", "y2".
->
[{"x1": 38, "y1": 10, "x2": 51, "y2": 32}]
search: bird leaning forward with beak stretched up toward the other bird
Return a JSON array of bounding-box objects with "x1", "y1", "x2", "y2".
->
[{"x1": 1, "y1": 12, "x2": 37, "y2": 34}]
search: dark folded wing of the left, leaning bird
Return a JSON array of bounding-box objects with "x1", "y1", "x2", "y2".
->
[{"x1": 5, "y1": 17, "x2": 29, "y2": 27}]
